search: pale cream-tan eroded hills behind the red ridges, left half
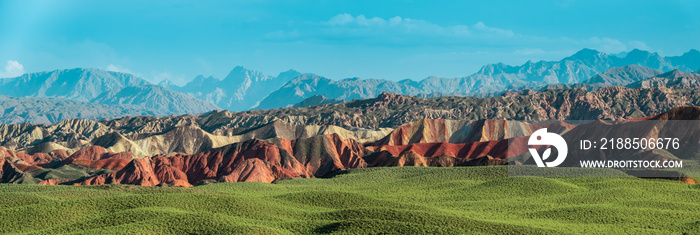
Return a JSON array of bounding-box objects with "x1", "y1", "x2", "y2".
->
[{"x1": 0, "y1": 113, "x2": 391, "y2": 157}]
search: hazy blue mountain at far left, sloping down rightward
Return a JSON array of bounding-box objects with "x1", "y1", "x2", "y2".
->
[{"x1": 0, "y1": 68, "x2": 219, "y2": 123}]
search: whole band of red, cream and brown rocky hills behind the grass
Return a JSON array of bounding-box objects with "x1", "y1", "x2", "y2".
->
[{"x1": 0, "y1": 81, "x2": 700, "y2": 186}]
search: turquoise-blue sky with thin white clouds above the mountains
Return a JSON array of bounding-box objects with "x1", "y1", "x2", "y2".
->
[{"x1": 0, "y1": 0, "x2": 700, "y2": 85}]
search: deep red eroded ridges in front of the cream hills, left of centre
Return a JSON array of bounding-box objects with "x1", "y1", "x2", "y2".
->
[{"x1": 73, "y1": 134, "x2": 367, "y2": 185}]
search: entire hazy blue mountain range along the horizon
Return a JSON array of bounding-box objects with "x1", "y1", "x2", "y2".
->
[{"x1": 0, "y1": 49, "x2": 700, "y2": 123}]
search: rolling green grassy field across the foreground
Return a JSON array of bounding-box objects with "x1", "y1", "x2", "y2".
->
[{"x1": 0, "y1": 167, "x2": 700, "y2": 234}]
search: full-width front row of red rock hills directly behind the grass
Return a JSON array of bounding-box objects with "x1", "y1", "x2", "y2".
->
[{"x1": 0, "y1": 107, "x2": 700, "y2": 187}]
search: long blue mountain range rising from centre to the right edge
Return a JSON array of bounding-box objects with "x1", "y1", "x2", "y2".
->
[{"x1": 255, "y1": 49, "x2": 700, "y2": 109}]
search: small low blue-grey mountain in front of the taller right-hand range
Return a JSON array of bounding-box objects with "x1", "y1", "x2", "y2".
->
[{"x1": 583, "y1": 65, "x2": 662, "y2": 86}]
